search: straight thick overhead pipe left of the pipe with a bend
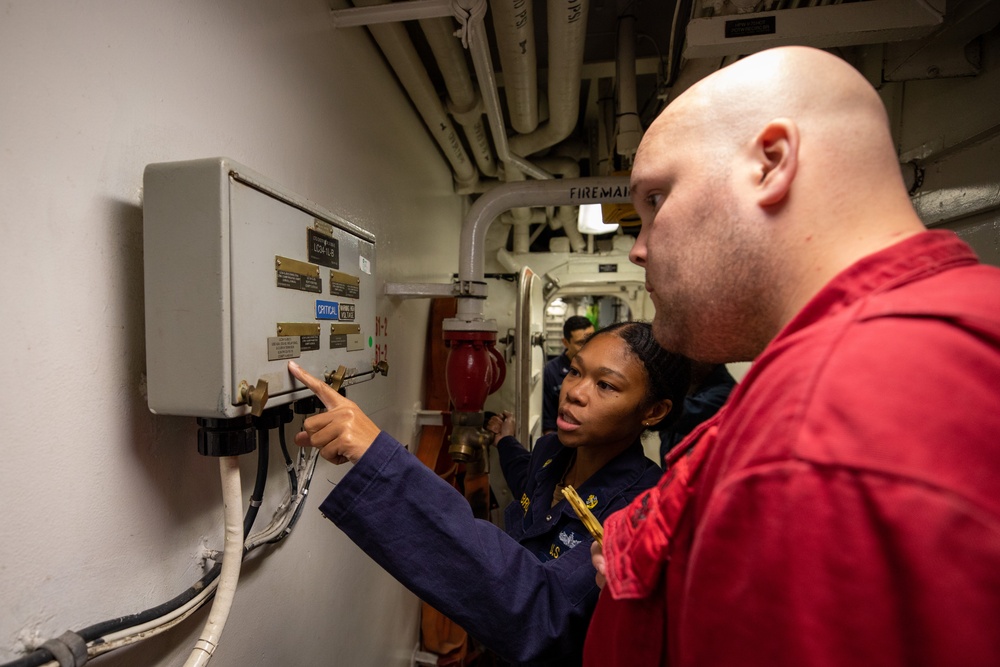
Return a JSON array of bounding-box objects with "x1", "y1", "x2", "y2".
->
[{"x1": 490, "y1": 0, "x2": 538, "y2": 134}]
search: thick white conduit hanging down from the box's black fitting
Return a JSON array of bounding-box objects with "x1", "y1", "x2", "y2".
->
[{"x1": 184, "y1": 456, "x2": 243, "y2": 667}]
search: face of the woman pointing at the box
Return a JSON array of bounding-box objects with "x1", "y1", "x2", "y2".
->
[{"x1": 556, "y1": 334, "x2": 648, "y2": 447}]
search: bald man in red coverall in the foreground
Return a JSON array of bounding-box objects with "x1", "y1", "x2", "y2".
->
[{"x1": 585, "y1": 47, "x2": 1000, "y2": 667}]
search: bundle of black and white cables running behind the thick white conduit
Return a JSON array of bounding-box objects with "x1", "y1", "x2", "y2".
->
[{"x1": 0, "y1": 425, "x2": 319, "y2": 667}]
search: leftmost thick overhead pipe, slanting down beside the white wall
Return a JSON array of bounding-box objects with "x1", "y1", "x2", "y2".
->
[{"x1": 355, "y1": 0, "x2": 479, "y2": 192}]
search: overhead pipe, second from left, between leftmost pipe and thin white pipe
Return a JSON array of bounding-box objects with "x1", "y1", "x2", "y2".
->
[{"x1": 420, "y1": 17, "x2": 497, "y2": 176}]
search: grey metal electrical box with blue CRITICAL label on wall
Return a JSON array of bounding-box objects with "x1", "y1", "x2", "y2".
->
[{"x1": 143, "y1": 157, "x2": 375, "y2": 419}]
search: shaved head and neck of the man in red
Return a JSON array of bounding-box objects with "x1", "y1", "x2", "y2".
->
[{"x1": 632, "y1": 47, "x2": 922, "y2": 361}]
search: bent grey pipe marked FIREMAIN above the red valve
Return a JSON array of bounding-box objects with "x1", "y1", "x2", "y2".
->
[{"x1": 455, "y1": 176, "x2": 630, "y2": 321}]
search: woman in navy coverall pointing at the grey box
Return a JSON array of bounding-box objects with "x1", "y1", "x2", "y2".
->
[{"x1": 289, "y1": 322, "x2": 689, "y2": 666}]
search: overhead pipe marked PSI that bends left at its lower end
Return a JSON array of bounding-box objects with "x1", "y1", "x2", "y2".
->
[{"x1": 504, "y1": 0, "x2": 589, "y2": 155}]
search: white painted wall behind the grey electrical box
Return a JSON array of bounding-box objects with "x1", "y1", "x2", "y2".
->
[{"x1": 0, "y1": 0, "x2": 464, "y2": 667}]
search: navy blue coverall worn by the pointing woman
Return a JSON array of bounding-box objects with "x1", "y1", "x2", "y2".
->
[{"x1": 320, "y1": 432, "x2": 660, "y2": 666}]
